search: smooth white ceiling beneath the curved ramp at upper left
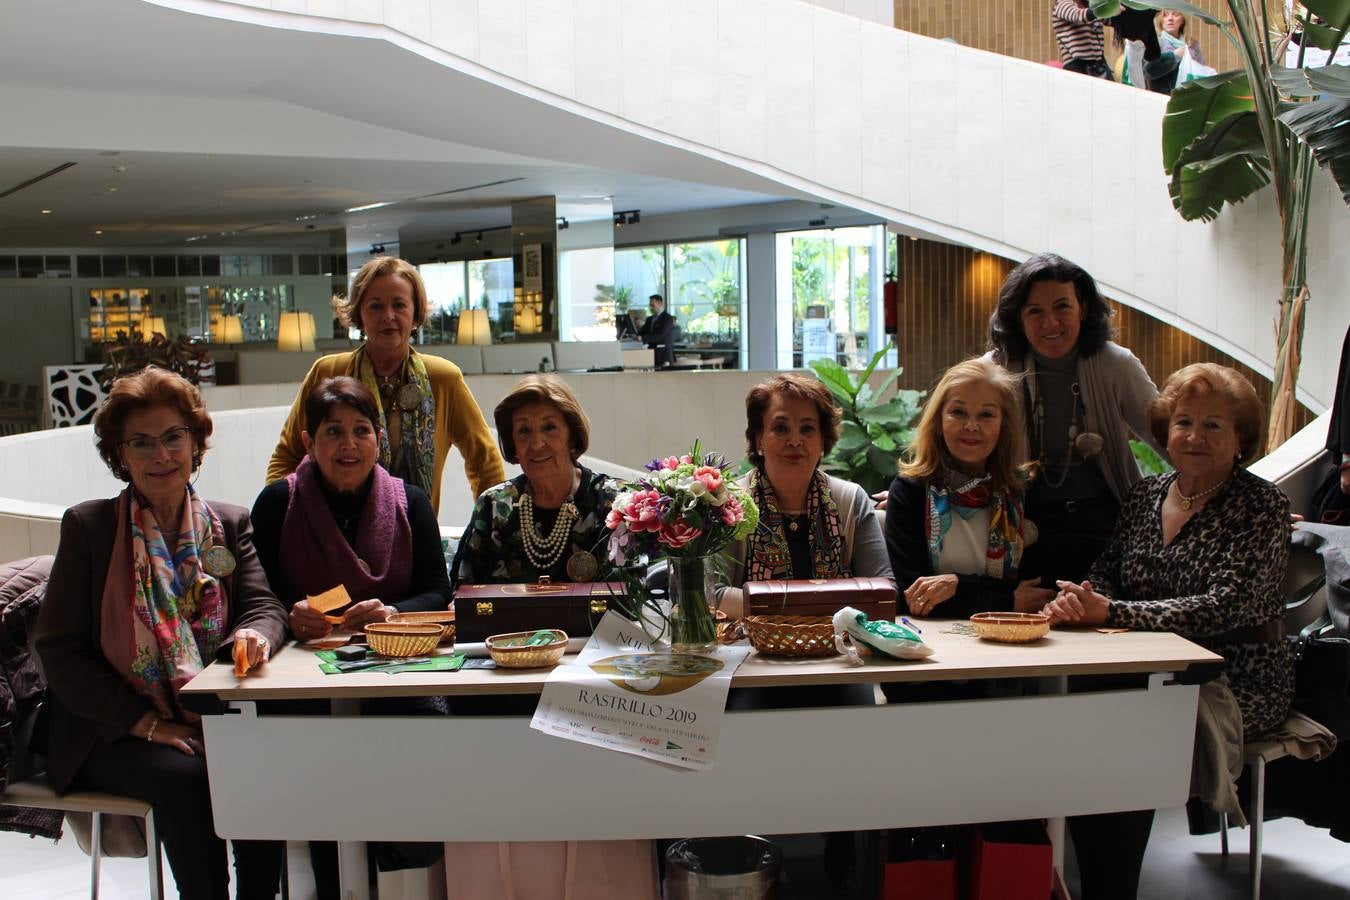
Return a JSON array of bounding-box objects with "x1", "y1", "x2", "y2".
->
[{"x1": 0, "y1": 0, "x2": 802, "y2": 248}]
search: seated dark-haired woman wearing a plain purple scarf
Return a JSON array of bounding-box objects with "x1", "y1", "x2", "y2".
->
[{"x1": 252, "y1": 376, "x2": 451, "y2": 641}]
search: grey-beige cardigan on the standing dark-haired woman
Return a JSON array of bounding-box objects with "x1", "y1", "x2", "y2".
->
[{"x1": 986, "y1": 341, "x2": 1166, "y2": 505}]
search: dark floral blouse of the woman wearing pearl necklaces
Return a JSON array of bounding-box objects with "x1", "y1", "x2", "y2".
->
[{"x1": 454, "y1": 467, "x2": 620, "y2": 584}]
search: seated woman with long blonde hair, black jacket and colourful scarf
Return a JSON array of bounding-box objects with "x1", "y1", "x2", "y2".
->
[{"x1": 886, "y1": 359, "x2": 1054, "y2": 618}]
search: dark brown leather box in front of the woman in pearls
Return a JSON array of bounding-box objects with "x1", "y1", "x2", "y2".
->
[{"x1": 455, "y1": 579, "x2": 624, "y2": 644}]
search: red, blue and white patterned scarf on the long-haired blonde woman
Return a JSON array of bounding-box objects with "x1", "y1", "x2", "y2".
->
[{"x1": 926, "y1": 463, "x2": 1025, "y2": 580}]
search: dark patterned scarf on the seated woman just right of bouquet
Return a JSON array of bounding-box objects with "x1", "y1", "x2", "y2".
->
[{"x1": 745, "y1": 470, "x2": 852, "y2": 582}]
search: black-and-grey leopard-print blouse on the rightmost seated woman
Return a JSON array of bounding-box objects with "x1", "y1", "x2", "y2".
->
[{"x1": 1088, "y1": 468, "x2": 1293, "y2": 737}]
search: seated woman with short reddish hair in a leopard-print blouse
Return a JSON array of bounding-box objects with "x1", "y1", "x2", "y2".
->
[{"x1": 1046, "y1": 363, "x2": 1293, "y2": 896}]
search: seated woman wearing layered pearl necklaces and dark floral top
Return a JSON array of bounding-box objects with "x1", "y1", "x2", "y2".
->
[{"x1": 454, "y1": 375, "x2": 618, "y2": 584}]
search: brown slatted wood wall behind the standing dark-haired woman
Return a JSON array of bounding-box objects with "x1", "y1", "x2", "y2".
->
[{"x1": 895, "y1": 236, "x2": 1314, "y2": 429}]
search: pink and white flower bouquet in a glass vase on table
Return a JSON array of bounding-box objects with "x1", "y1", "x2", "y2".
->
[{"x1": 605, "y1": 441, "x2": 759, "y2": 653}]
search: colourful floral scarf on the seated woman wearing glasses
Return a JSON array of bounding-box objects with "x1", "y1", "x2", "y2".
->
[{"x1": 100, "y1": 484, "x2": 227, "y2": 722}]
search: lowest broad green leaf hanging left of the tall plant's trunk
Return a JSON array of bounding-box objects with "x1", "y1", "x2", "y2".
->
[{"x1": 1169, "y1": 112, "x2": 1270, "y2": 221}]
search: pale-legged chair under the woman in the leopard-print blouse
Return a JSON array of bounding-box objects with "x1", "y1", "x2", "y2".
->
[{"x1": 1219, "y1": 545, "x2": 1327, "y2": 900}]
